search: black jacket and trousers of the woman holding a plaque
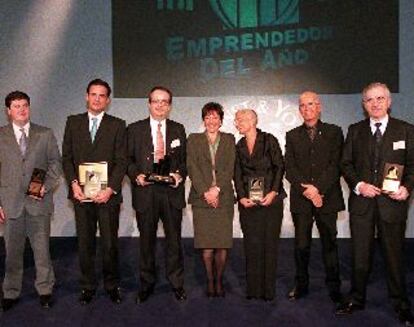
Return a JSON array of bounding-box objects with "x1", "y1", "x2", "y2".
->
[{"x1": 234, "y1": 129, "x2": 286, "y2": 300}]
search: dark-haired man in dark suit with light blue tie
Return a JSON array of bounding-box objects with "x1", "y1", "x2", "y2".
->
[{"x1": 62, "y1": 79, "x2": 127, "y2": 304}]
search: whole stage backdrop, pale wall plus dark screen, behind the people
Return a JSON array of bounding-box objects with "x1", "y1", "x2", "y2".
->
[{"x1": 0, "y1": 0, "x2": 414, "y2": 237}]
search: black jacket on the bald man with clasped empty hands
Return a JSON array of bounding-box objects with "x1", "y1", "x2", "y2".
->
[{"x1": 285, "y1": 121, "x2": 345, "y2": 213}]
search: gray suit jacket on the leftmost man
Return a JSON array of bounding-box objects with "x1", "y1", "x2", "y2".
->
[{"x1": 0, "y1": 123, "x2": 62, "y2": 218}]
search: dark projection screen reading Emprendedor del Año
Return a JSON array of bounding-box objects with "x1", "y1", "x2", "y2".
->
[{"x1": 112, "y1": 0, "x2": 398, "y2": 98}]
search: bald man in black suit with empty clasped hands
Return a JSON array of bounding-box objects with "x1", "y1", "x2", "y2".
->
[{"x1": 286, "y1": 91, "x2": 345, "y2": 303}]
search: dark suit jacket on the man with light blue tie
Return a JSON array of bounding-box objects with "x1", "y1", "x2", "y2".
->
[{"x1": 62, "y1": 112, "x2": 127, "y2": 205}]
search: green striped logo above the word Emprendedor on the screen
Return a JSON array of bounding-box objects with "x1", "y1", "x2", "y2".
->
[{"x1": 210, "y1": 0, "x2": 299, "y2": 29}]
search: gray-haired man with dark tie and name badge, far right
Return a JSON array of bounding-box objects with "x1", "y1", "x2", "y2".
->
[{"x1": 337, "y1": 83, "x2": 414, "y2": 324}]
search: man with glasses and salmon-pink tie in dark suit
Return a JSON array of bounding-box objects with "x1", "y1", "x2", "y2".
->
[{"x1": 128, "y1": 86, "x2": 187, "y2": 303}]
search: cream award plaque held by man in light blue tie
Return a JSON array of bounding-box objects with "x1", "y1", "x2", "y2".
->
[{"x1": 79, "y1": 161, "x2": 108, "y2": 202}]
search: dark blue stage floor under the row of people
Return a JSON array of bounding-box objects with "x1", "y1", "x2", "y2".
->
[{"x1": 0, "y1": 238, "x2": 414, "y2": 327}]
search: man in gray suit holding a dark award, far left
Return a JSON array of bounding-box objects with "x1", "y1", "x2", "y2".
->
[{"x1": 0, "y1": 91, "x2": 62, "y2": 311}]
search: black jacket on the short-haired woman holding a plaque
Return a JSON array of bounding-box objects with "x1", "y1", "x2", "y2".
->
[{"x1": 234, "y1": 129, "x2": 286, "y2": 202}]
